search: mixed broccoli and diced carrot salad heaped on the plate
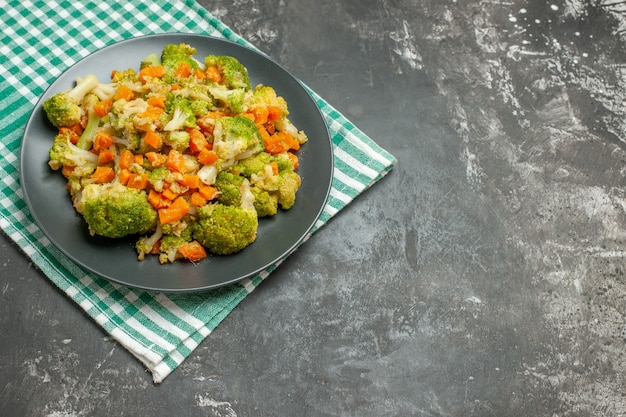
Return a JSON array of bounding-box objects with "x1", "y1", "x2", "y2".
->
[{"x1": 43, "y1": 43, "x2": 307, "y2": 263}]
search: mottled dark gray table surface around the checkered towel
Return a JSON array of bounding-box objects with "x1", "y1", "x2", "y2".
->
[{"x1": 0, "y1": 0, "x2": 626, "y2": 417}]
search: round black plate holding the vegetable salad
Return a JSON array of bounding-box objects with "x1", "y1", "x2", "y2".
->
[{"x1": 20, "y1": 33, "x2": 333, "y2": 292}]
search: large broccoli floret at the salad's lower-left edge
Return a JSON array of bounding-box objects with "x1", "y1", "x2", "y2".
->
[{"x1": 80, "y1": 182, "x2": 157, "y2": 238}]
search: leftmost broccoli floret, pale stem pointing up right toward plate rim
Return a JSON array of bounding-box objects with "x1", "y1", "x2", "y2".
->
[{"x1": 43, "y1": 74, "x2": 99, "y2": 127}]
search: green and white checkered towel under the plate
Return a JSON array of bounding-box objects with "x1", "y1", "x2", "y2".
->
[{"x1": 0, "y1": 0, "x2": 396, "y2": 383}]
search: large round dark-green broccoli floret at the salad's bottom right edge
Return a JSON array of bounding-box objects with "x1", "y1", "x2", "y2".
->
[{"x1": 193, "y1": 204, "x2": 259, "y2": 255}]
